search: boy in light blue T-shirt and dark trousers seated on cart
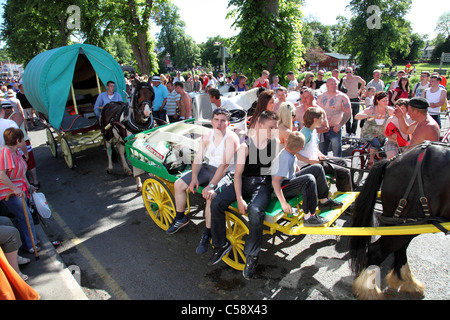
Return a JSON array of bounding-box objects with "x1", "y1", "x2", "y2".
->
[{"x1": 272, "y1": 131, "x2": 343, "y2": 227}]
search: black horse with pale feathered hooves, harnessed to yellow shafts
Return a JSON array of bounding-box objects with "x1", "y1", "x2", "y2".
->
[{"x1": 349, "y1": 142, "x2": 450, "y2": 299}]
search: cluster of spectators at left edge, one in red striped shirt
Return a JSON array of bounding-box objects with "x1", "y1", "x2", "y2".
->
[{"x1": 0, "y1": 81, "x2": 40, "y2": 280}]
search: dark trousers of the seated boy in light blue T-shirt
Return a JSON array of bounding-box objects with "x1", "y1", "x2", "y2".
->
[{"x1": 281, "y1": 164, "x2": 329, "y2": 214}]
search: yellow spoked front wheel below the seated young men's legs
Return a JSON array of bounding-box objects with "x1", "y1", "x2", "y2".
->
[{"x1": 222, "y1": 211, "x2": 249, "y2": 270}]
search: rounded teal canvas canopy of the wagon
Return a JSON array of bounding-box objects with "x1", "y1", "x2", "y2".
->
[{"x1": 23, "y1": 44, "x2": 126, "y2": 129}]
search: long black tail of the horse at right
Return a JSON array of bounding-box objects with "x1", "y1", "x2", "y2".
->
[{"x1": 349, "y1": 160, "x2": 390, "y2": 275}]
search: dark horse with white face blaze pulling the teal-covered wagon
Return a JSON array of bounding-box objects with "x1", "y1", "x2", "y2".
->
[{"x1": 99, "y1": 82, "x2": 155, "y2": 189}]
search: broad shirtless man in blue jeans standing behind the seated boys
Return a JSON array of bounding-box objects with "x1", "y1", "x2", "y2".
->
[{"x1": 317, "y1": 77, "x2": 352, "y2": 157}]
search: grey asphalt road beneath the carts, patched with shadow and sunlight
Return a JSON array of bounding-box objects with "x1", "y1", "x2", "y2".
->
[{"x1": 30, "y1": 122, "x2": 450, "y2": 300}]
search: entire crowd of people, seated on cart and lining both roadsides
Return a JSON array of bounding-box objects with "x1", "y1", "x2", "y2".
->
[{"x1": 0, "y1": 63, "x2": 447, "y2": 290}]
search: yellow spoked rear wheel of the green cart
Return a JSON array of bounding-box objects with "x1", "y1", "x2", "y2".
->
[{"x1": 142, "y1": 177, "x2": 176, "y2": 231}]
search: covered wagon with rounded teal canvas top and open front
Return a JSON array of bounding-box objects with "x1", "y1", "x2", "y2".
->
[{"x1": 23, "y1": 44, "x2": 125, "y2": 168}]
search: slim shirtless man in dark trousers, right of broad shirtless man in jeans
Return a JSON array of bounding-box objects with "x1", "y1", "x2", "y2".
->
[{"x1": 342, "y1": 67, "x2": 366, "y2": 137}]
